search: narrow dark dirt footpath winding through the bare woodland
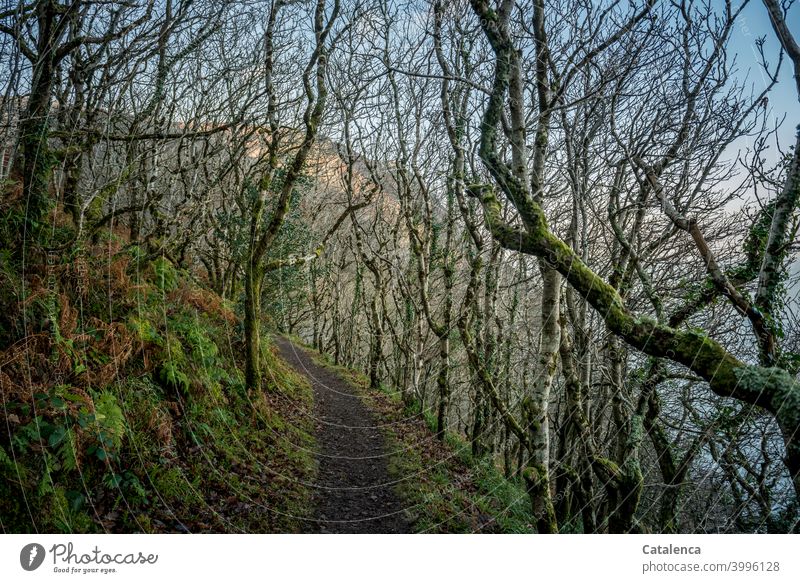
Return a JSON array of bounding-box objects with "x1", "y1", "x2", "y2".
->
[{"x1": 275, "y1": 338, "x2": 410, "y2": 533}]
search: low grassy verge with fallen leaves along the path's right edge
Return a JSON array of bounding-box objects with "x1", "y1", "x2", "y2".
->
[{"x1": 312, "y1": 344, "x2": 535, "y2": 533}]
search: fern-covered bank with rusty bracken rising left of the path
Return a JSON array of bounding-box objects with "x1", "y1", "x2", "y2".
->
[{"x1": 0, "y1": 238, "x2": 316, "y2": 533}]
